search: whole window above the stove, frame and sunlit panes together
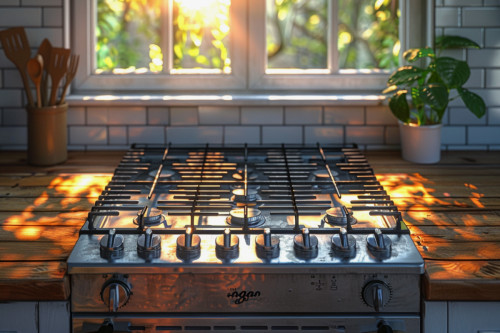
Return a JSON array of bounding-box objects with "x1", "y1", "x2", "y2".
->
[{"x1": 72, "y1": 0, "x2": 425, "y2": 93}]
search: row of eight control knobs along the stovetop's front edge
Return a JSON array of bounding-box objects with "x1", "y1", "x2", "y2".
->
[{"x1": 100, "y1": 227, "x2": 392, "y2": 261}]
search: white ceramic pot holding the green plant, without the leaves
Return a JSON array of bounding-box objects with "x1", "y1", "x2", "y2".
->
[{"x1": 399, "y1": 121, "x2": 442, "y2": 164}]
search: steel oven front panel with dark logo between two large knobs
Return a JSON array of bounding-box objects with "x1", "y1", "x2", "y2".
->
[{"x1": 71, "y1": 269, "x2": 420, "y2": 313}]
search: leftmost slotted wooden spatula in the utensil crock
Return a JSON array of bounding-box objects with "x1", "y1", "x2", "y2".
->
[{"x1": 0, "y1": 27, "x2": 33, "y2": 106}]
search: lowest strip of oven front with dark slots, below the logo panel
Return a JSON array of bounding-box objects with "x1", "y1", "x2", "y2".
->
[{"x1": 73, "y1": 315, "x2": 420, "y2": 333}]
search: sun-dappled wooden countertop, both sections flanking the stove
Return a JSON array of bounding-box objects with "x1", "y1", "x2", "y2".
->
[{"x1": 0, "y1": 151, "x2": 500, "y2": 301}]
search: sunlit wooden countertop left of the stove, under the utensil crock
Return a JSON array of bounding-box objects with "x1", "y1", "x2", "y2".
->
[{"x1": 0, "y1": 151, "x2": 120, "y2": 301}]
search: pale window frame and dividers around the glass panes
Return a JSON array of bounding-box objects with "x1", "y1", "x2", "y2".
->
[{"x1": 70, "y1": 0, "x2": 434, "y2": 94}]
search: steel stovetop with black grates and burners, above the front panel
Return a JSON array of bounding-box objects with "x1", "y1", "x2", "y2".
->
[{"x1": 68, "y1": 144, "x2": 423, "y2": 268}]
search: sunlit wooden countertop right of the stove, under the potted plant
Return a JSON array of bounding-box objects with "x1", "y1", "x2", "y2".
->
[{"x1": 366, "y1": 152, "x2": 500, "y2": 301}]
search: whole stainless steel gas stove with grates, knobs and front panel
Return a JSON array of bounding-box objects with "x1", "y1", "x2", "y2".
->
[{"x1": 68, "y1": 145, "x2": 423, "y2": 332}]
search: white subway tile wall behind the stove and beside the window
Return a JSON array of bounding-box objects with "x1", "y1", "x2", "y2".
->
[{"x1": 0, "y1": 0, "x2": 500, "y2": 151}]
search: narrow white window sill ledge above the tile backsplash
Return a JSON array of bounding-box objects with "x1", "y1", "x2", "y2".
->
[{"x1": 66, "y1": 93, "x2": 385, "y2": 106}]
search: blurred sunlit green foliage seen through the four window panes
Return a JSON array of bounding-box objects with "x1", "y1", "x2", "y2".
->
[{"x1": 96, "y1": 0, "x2": 399, "y2": 73}]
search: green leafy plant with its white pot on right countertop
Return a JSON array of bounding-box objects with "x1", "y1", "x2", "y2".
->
[{"x1": 383, "y1": 36, "x2": 486, "y2": 163}]
